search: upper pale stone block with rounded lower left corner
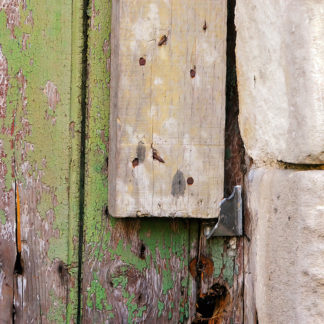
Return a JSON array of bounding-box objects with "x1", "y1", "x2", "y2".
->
[{"x1": 235, "y1": 0, "x2": 324, "y2": 163}]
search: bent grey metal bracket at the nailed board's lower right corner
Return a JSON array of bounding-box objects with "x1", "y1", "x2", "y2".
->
[{"x1": 204, "y1": 186, "x2": 243, "y2": 239}]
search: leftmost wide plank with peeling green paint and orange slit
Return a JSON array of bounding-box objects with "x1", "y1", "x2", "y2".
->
[{"x1": 0, "y1": 0, "x2": 81, "y2": 323}]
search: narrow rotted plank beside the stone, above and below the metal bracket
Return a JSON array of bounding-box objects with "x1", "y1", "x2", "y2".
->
[{"x1": 190, "y1": 0, "x2": 244, "y2": 324}]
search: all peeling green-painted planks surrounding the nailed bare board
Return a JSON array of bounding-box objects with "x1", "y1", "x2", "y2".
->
[{"x1": 0, "y1": 0, "x2": 242, "y2": 323}]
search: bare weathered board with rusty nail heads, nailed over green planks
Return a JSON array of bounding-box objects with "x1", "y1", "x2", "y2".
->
[{"x1": 109, "y1": 0, "x2": 226, "y2": 218}]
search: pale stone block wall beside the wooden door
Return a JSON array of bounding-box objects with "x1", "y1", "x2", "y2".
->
[{"x1": 235, "y1": 0, "x2": 324, "y2": 324}]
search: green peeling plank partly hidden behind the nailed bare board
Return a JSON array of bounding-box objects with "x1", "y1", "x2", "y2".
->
[{"x1": 82, "y1": 0, "x2": 202, "y2": 323}]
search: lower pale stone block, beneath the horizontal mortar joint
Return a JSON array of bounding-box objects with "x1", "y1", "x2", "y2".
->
[{"x1": 245, "y1": 168, "x2": 324, "y2": 324}]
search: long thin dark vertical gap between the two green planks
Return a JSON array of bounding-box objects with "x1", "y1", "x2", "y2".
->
[{"x1": 77, "y1": 0, "x2": 90, "y2": 323}]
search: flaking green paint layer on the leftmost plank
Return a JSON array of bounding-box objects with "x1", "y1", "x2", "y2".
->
[{"x1": 0, "y1": 0, "x2": 82, "y2": 320}]
